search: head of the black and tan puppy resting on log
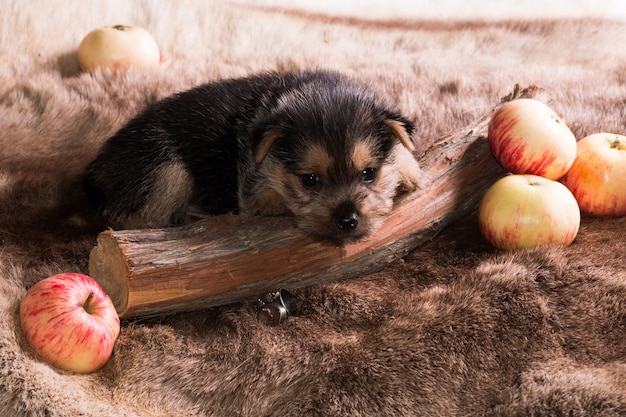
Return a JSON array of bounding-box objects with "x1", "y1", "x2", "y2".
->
[{"x1": 241, "y1": 74, "x2": 419, "y2": 243}]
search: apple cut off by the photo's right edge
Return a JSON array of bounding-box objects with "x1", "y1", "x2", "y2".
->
[{"x1": 561, "y1": 133, "x2": 626, "y2": 217}]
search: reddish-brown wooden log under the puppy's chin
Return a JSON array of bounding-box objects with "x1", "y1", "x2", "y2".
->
[{"x1": 89, "y1": 86, "x2": 548, "y2": 318}]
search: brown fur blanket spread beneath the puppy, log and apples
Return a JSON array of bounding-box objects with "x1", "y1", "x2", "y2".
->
[{"x1": 0, "y1": 0, "x2": 626, "y2": 417}]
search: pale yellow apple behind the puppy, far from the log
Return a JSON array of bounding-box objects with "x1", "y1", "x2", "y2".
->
[{"x1": 77, "y1": 25, "x2": 161, "y2": 71}]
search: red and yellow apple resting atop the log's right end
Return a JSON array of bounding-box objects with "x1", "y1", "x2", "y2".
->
[{"x1": 487, "y1": 98, "x2": 576, "y2": 180}]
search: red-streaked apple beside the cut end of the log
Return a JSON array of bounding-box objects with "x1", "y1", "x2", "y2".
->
[{"x1": 20, "y1": 273, "x2": 120, "y2": 373}]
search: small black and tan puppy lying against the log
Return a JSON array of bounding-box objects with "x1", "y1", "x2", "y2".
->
[{"x1": 85, "y1": 71, "x2": 421, "y2": 243}]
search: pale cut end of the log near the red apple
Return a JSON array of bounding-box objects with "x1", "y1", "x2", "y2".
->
[{"x1": 89, "y1": 230, "x2": 130, "y2": 317}]
